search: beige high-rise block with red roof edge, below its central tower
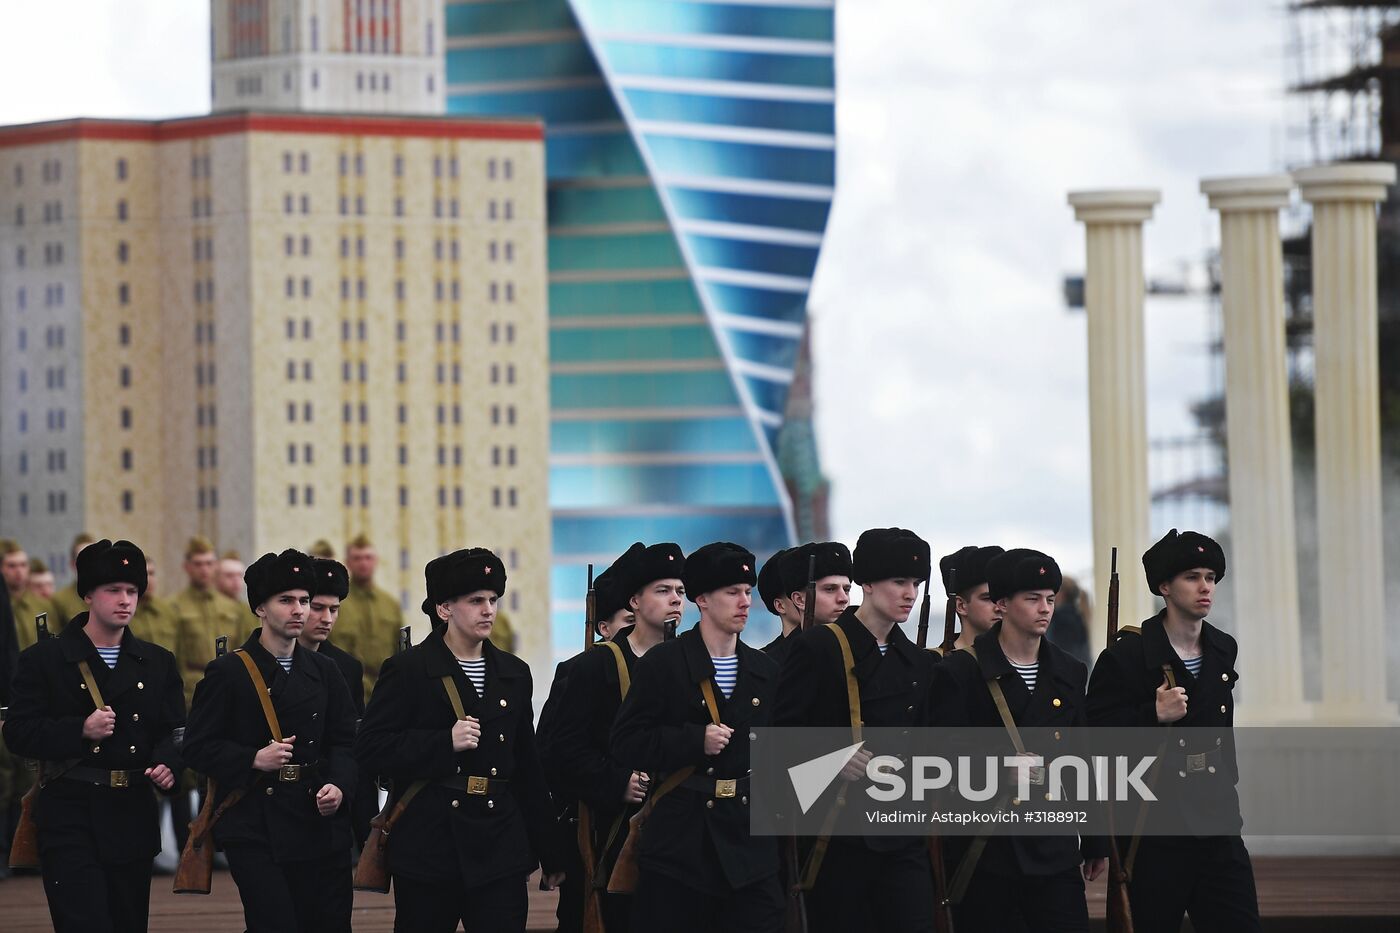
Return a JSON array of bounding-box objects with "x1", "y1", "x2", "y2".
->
[{"x1": 0, "y1": 112, "x2": 550, "y2": 664}]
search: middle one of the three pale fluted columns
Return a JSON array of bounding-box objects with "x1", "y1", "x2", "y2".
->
[{"x1": 1201, "y1": 175, "x2": 1310, "y2": 723}]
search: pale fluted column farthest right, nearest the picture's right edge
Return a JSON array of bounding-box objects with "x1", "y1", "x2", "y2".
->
[{"x1": 1294, "y1": 163, "x2": 1397, "y2": 723}]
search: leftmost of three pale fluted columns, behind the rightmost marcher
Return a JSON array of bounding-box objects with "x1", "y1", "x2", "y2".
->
[{"x1": 1070, "y1": 189, "x2": 1162, "y2": 647}]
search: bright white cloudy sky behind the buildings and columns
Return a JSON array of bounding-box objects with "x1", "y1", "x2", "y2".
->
[{"x1": 0, "y1": 0, "x2": 1285, "y2": 582}]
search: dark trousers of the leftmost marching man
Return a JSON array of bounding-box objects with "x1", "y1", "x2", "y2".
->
[{"x1": 39, "y1": 831, "x2": 151, "y2": 933}]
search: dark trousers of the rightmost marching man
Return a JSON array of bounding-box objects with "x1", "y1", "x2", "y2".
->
[{"x1": 1124, "y1": 836, "x2": 1261, "y2": 933}]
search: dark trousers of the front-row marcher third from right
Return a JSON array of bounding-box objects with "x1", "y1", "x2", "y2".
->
[{"x1": 804, "y1": 839, "x2": 934, "y2": 933}]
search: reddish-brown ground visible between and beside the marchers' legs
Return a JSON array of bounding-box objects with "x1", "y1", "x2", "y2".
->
[{"x1": 0, "y1": 857, "x2": 1400, "y2": 933}]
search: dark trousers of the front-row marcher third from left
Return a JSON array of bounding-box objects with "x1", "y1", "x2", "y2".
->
[{"x1": 393, "y1": 876, "x2": 529, "y2": 933}]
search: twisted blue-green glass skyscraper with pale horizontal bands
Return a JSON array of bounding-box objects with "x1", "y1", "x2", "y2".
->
[{"x1": 447, "y1": 0, "x2": 836, "y2": 654}]
